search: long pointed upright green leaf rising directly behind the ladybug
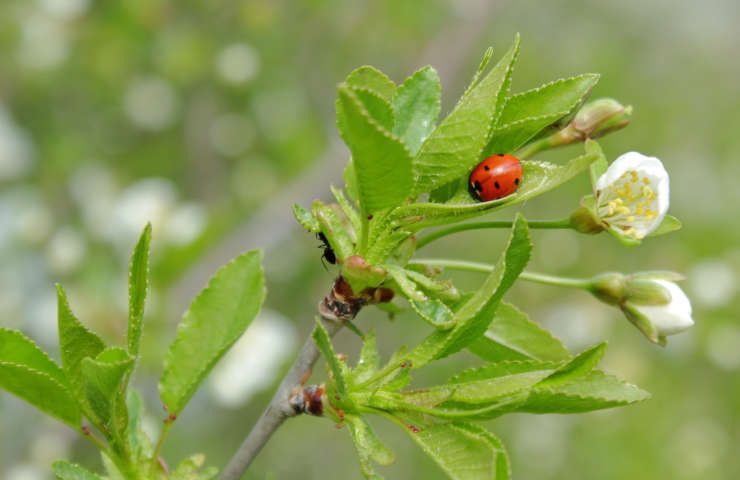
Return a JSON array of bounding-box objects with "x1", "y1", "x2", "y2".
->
[{"x1": 414, "y1": 37, "x2": 519, "y2": 196}]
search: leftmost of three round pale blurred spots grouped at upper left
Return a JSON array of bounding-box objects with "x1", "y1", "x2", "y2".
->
[{"x1": 123, "y1": 75, "x2": 177, "y2": 130}]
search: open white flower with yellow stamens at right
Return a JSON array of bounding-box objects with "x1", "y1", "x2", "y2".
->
[{"x1": 596, "y1": 152, "x2": 670, "y2": 240}]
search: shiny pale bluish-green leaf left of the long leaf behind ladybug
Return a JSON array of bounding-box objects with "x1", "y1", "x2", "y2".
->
[{"x1": 391, "y1": 66, "x2": 442, "y2": 154}]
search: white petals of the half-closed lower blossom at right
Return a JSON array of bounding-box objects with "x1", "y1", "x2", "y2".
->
[{"x1": 634, "y1": 279, "x2": 694, "y2": 337}]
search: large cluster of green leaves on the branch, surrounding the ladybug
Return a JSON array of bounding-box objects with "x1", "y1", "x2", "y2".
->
[{"x1": 295, "y1": 38, "x2": 648, "y2": 479}]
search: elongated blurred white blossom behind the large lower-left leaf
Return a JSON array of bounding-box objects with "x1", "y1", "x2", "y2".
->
[{"x1": 209, "y1": 310, "x2": 297, "y2": 408}]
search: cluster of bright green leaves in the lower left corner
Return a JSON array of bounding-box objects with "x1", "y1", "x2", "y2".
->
[{"x1": 0, "y1": 226, "x2": 265, "y2": 480}]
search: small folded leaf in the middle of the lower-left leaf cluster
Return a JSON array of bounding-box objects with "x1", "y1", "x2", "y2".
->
[{"x1": 80, "y1": 347, "x2": 134, "y2": 451}]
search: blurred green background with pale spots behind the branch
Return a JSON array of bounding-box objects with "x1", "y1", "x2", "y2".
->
[{"x1": 0, "y1": 0, "x2": 740, "y2": 480}]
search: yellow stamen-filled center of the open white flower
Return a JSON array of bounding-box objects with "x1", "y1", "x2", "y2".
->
[{"x1": 597, "y1": 170, "x2": 658, "y2": 240}]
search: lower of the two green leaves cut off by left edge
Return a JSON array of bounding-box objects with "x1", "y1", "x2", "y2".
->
[{"x1": 0, "y1": 361, "x2": 82, "y2": 430}]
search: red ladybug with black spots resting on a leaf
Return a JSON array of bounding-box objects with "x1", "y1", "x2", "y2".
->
[{"x1": 469, "y1": 153, "x2": 522, "y2": 202}]
